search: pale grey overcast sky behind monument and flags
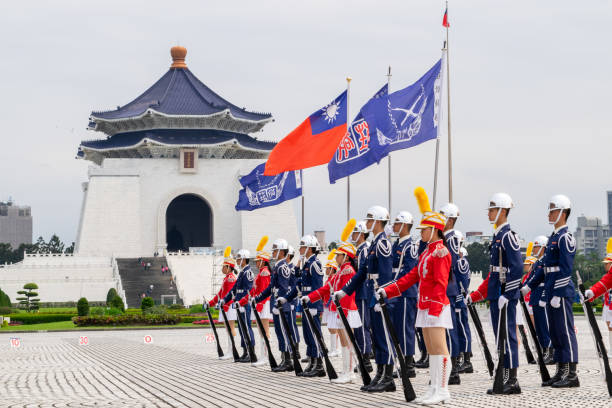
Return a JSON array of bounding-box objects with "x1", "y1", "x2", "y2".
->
[{"x1": 0, "y1": 0, "x2": 612, "y2": 245}]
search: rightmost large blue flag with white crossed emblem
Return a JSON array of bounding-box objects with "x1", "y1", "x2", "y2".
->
[{"x1": 361, "y1": 59, "x2": 442, "y2": 156}]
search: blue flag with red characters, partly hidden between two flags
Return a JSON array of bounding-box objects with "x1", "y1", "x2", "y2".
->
[{"x1": 327, "y1": 84, "x2": 388, "y2": 184}]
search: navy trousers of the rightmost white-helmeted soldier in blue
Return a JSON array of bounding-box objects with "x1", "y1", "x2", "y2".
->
[{"x1": 546, "y1": 297, "x2": 578, "y2": 363}]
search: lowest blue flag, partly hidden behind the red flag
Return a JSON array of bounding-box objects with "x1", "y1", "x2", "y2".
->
[{"x1": 236, "y1": 163, "x2": 302, "y2": 211}]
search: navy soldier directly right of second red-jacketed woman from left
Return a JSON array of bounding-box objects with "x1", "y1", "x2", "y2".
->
[{"x1": 255, "y1": 239, "x2": 293, "y2": 372}]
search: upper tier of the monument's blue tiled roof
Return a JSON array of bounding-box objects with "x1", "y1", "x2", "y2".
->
[{"x1": 91, "y1": 68, "x2": 272, "y2": 122}]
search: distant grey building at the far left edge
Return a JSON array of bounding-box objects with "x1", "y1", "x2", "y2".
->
[{"x1": 0, "y1": 200, "x2": 32, "y2": 249}]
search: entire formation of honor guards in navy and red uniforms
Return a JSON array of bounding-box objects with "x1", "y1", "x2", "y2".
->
[{"x1": 205, "y1": 188, "x2": 612, "y2": 404}]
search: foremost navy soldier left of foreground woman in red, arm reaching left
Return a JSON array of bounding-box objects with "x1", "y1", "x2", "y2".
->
[{"x1": 335, "y1": 205, "x2": 395, "y2": 392}]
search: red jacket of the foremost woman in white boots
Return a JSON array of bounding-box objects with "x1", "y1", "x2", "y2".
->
[{"x1": 385, "y1": 240, "x2": 452, "y2": 316}]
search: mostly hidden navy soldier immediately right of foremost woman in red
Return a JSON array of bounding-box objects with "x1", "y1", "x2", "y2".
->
[{"x1": 455, "y1": 242, "x2": 474, "y2": 374}]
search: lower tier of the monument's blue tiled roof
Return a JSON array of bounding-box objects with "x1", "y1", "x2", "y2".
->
[{"x1": 80, "y1": 129, "x2": 276, "y2": 151}]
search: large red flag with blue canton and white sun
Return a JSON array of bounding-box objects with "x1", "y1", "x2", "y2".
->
[{"x1": 264, "y1": 91, "x2": 347, "y2": 176}]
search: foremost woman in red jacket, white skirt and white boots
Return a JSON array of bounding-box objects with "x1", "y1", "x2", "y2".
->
[{"x1": 377, "y1": 211, "x2": 453, "y2": 405}]
